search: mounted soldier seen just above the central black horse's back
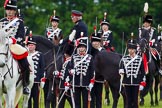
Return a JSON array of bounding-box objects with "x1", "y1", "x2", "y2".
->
[{"x1": 101, "y1": 13, "x2": 114, "y2": 51}]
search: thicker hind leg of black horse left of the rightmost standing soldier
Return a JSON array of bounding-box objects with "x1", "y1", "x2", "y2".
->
[{"x1": 109, "y1": 82, "x2": 120, "y2": 108}]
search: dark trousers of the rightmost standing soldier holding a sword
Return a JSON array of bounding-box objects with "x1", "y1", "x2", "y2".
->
[{"x1": 125, "y1": 85, "x2": 139, "y2": 108}]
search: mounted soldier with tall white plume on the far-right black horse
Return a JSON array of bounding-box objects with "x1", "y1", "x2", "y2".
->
[{"x1": 139, "y1": 14, "x2": 161, "y2": 73}]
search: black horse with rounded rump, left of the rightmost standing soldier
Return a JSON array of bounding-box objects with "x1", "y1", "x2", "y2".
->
[{"x1": 95, "y1": 50, "x2": 126, "y2": 108}]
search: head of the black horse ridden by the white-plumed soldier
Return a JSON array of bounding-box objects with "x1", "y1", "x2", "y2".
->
[{"x1": 139, "y1": 38, "x2": 149, "y2": 53}]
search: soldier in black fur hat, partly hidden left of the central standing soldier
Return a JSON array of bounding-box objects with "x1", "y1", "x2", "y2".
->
[{"x1": 54, "y1": 43, "x2": 74, "y2": 108}]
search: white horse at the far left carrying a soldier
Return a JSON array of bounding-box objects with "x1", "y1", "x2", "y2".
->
[{"x1": 0, "y1": 34, "x2": 34, "y2": 108}]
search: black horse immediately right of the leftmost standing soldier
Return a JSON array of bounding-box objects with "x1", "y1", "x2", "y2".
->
[{"x1": 33, "y1": 36, "x2": 64, "y2": 108}]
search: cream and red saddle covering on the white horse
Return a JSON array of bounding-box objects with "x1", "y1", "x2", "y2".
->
[{"x1": 9, "y1": 44, "x2": 28, "y2": 60}]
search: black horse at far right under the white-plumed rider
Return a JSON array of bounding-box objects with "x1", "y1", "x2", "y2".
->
[{"x1": 139, "y1": 38, "x2": 160, "y2": 106}]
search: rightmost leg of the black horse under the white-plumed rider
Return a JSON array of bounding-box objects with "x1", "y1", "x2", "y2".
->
[{"x1": 154, "y1": 75, "x2": 160, "y2": 105}]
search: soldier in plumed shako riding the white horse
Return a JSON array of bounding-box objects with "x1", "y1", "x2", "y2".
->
[{"x1": 0, "y1": 0, "x2": 31, "y2": 94}]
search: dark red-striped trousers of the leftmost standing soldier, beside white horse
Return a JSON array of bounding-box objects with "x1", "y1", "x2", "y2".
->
[{"x1": 28, "y1": 83, "x2": 40, "y2": 108}]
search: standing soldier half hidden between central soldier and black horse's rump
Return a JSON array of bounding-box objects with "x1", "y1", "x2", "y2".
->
[{"x1": 91, "y1": 33, "x2": 105, "y2": 108}]
